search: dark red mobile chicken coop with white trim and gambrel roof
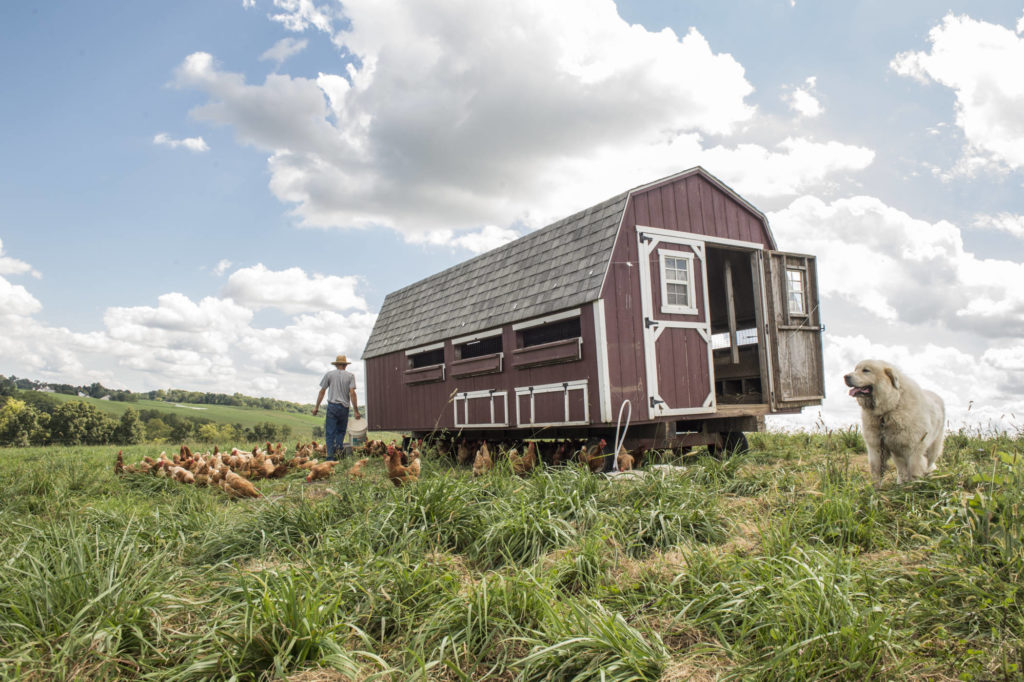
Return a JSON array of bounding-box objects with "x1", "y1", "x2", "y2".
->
[{"x1": 362, "y1": 167, "x2": 824, "y2": 449}]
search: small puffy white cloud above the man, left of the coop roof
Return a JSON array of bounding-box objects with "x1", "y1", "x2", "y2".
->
[{"x1": 221, "y1": 263, "x2": 367, "y2": 314}]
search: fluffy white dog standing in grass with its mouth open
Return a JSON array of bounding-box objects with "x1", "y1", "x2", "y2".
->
[{"x1": 843, "y1": 359, "x2": 946, "y2": 484}]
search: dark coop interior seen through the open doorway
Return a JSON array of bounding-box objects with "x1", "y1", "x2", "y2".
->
[{"x1": 708, "y1": 248, "x2": 764, "y2": 404}]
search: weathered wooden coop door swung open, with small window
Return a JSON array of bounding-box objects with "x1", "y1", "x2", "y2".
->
[{"x1": 764, "y1": 251, "x2": 825, "y2": 411}]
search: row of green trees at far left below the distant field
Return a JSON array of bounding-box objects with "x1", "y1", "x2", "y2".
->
[{"x1": 0, "y1": 376, "x2": 292, "y2": 446}]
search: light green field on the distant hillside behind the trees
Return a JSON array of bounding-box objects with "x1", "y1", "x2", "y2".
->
[{"x1": 47, "y1": 393, "x2": 324, "y2": 440}]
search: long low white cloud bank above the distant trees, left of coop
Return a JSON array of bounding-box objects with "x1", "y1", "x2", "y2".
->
[{"x1": 0, "y1": 238, "x2": 376, "y2": 402}]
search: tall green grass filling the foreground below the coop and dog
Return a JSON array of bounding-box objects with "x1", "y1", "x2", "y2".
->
[{"x1": 0, "y1": 432, "x2": 1024, "y2": 681}]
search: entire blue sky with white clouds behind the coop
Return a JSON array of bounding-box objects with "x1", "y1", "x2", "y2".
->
[{"x1": 0, "y1": 0, "x2": 1024, "y2": 428}]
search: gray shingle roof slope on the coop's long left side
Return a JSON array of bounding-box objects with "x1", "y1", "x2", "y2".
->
[{"x1": 362, "y1": 187, "x2": 630, "y2": 358}]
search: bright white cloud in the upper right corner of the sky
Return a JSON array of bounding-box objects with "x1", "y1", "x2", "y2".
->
[{"x1": 890, "y1": 14, "x2": 1024, "y2": 175}]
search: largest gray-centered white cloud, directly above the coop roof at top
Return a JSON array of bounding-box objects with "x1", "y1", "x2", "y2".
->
[{"x1": 175, "y1": 0, "x2": 755, "y2": 236}]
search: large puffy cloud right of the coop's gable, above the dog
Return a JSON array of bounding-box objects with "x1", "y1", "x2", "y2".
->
[{"x1": 770, "y1": 192, "x2": 1024, "y2": 338}]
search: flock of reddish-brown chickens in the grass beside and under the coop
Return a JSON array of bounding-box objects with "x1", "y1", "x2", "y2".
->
[{"x1": 114, "y1": 438, "x2": 635, "y2": 498}]
